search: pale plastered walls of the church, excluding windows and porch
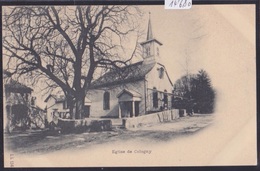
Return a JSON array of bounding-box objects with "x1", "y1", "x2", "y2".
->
[{"x1": 87, "y1": 61, "x2": 172, "y2": 118}]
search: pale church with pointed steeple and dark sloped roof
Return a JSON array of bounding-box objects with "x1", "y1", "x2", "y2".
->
[{"x1": 85, "y1": 15, "x2": 173, "y2": 118}]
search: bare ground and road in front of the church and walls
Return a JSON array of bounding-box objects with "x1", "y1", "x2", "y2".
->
[{"x1": 4, "y1": 114, "x2": 214, "y2": 154}]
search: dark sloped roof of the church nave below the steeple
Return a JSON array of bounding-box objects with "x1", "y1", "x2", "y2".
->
[{"x1": 91, "y1": 61, "x2": 155, "y2": 89}]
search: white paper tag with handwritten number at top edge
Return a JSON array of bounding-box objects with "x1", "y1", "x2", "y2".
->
[{"x1": 164, "y1": 0, "x2": 192, "y2": 9}]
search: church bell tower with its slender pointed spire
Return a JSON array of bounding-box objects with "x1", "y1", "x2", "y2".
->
[{"x1": 140, "y1": 12, "x2": 162, "y2": 64}]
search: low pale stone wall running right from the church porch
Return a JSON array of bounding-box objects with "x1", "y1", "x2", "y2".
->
[{"x1": 123, "y1": 109, "x2": 186, "y2": 129}]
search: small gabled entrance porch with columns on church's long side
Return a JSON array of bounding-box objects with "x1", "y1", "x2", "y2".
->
[{"x1": 117, "y1": 89, "x2": 141, "y2": 118}]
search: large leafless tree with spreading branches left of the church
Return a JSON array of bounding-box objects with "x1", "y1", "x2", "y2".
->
[{"x1": 3, "y1": 6, "x2": 142, "y2": 118}]
